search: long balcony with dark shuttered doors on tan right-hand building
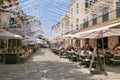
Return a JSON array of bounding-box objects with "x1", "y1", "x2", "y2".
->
[{"x1": 81, "y1": 9, "x2": 120, "y2": 28}]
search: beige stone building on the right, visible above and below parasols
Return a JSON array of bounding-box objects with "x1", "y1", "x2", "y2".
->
[{"x1": 70, "y1": 0, "x2": 120, "y2": 49}]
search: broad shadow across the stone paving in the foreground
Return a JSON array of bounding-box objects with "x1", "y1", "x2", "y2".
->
[{"x1": 0, "y1": 61, "x2": 90, "y2": 80}]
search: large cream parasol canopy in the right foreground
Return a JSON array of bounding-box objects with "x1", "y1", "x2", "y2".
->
[{"x1": 74, "y1": 23, "x2": 120, "y2": 39}]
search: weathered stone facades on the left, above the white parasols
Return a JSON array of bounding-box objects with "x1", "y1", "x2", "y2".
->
[{"x1": 0, "y1": 0, "x2": 43, "y2": 36}]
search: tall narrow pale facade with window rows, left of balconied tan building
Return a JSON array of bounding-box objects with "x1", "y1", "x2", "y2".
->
[{"x1": 70, "y1": 0, "x2": 85, "y2": 32}]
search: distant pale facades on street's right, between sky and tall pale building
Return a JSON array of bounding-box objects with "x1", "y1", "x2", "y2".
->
[{"x1": 51, "y1": 12, "x2": 70, "y2": 47}]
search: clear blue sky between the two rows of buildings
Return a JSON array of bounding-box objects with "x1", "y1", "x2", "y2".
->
[{"x1": 18, "y1": 0, "x2": 70, "y2": 38}]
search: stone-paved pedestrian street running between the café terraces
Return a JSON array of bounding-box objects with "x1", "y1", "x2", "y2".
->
[{"x1": 0, "y1": 49, "x2": 90, "y2": 80}]
